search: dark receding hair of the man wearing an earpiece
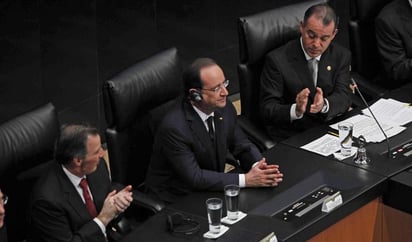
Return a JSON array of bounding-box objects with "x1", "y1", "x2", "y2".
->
[{"x1": 183, "y1": 58, "x2": 217, "y2": 96}]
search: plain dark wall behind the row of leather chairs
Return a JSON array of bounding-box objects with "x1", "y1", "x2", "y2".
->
[{"x1": 0, "y1": 0, "x2": 349, "y2": 138}]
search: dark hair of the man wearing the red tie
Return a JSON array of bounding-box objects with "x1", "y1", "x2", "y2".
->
[{"x1": 54, "y1": 124, "x2": 99, "y2": 165}]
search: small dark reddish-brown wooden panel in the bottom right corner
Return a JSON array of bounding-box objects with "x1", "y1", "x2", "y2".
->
[{"x1": 382, "y1": 205, "x2": 412, "y2": 242}]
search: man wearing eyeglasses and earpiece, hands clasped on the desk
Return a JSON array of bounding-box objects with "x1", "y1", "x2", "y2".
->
[{"x1": 146, "y1": 58, "x2": 283, "y2": 203}]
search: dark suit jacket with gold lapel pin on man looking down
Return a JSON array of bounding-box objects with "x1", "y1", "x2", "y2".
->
[{"x1": 260, "y1": 39, "x2": 351, "y2": 139}]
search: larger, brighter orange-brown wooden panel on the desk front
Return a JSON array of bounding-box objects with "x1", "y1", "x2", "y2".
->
[{"x1": 308, "y1": 198, "x2": 382, "y2": 242}]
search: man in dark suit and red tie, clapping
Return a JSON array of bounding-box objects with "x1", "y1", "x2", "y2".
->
[{"x1": 30, "y1": 125, "x2": 133, "y2": 242}]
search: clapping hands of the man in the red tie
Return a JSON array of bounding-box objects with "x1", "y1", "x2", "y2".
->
[{"x1": 97, "y1": 185, "x2": 133, "y2": 226}]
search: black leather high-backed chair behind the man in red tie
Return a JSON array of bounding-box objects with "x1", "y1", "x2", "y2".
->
[{"x1": 0, "y1": 103, "x2": 59, "y2": 241}]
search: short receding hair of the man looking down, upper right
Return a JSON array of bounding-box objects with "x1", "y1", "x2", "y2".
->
[{"x1": 303, "y1": 3, "x2": 339, "y2": 29}]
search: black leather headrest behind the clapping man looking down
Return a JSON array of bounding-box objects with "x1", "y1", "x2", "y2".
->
[{"x1": 238, "y1": 0, "x2": 325, "y2": 64}]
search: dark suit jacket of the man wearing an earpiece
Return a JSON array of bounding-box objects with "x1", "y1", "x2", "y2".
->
[{"x1": 146, "y1": 100, "x2": 262, "y2": 202}]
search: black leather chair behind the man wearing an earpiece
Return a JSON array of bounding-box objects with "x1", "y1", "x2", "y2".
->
[{"x1": 103, "y1": 48, "x2": 183, "y2": 219}]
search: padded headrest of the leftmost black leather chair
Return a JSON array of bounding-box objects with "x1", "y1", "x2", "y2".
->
[{"x1": 0, "y1": 103, "x2": 59, "y2": 177}]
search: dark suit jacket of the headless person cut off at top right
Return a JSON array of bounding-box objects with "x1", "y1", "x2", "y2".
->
[{"x1": 375, "y1": 0, "x2": 412, "y2": 88}]
